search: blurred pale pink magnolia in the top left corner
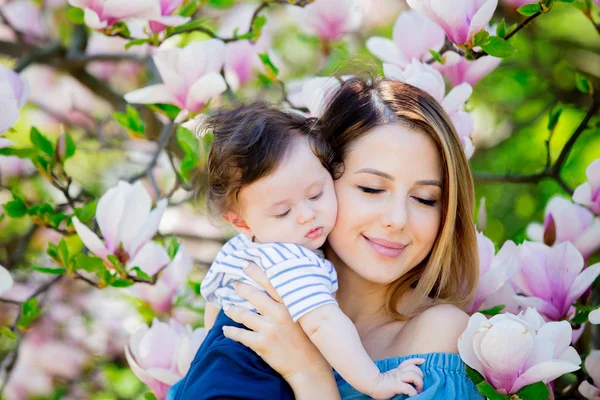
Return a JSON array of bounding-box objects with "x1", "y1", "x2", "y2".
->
[{"x1": 0, "y1": 0, "x2": 48, "y2": 38}]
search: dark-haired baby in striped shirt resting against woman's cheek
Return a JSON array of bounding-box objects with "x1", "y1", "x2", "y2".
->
[{"x1": 201, "y1": 103, "x2": 424, "y2": 399}]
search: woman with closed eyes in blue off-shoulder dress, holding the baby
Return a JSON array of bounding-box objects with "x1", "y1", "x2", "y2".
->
[{"x1": 173, "y1": 78, "x2": 482, "y2": 399}]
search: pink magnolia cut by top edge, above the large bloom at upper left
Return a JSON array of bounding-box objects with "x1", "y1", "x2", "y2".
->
[{"x1": 69, "y1": 0, "x2": 160, "y2": 29}]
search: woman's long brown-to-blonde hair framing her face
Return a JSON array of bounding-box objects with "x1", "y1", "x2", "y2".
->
[{"x1": 320, "y1": 78, "x2": 479, "y2": 319}]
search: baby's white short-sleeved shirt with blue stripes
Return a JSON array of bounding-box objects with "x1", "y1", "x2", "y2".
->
[{"x1": 200, "y1": 234, "x2": 338, "y2": 322}]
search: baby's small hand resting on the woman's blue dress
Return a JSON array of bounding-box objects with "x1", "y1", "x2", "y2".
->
[{"x1": 371, "y1": 358, "x2": 425, "y2": 399}]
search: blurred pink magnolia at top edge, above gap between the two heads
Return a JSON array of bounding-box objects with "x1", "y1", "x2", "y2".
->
[{"x1": 299, "y1": 0, "x2": 361, "y2": 40}]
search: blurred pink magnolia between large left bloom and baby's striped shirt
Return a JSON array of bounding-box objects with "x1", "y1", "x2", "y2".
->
[{"x1": 131, "y1": 244, "x2": 193, "y2": 313}]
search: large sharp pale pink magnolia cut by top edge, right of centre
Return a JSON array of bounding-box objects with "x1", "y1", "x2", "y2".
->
[{"x1": 406, "y1": 0, "x2": 498, "y2": 45}]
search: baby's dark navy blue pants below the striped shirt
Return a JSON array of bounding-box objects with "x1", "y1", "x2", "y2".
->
[{"x1": 167, "y1": 310, "x2": 294, "y2": 400}]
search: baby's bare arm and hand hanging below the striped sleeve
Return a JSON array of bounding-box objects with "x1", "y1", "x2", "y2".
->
[{"x1": 299, "y1": 304, "x2": 424, "y2": 399}]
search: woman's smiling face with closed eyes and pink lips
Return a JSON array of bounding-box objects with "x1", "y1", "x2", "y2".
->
[{"x1": 328, "y1": 124, "x2": 442, "y2": 284}]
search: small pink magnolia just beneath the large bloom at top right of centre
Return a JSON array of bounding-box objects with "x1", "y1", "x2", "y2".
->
[{"x1": 434, "y1": 51, "x2": 502, "y2": 86}]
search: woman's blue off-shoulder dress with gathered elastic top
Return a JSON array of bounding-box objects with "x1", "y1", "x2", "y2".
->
[{"x1": 335, "y1": 353, "x2": 485, "y2": 400}]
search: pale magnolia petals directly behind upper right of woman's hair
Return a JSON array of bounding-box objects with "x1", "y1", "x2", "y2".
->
[{"x1": 383, "y1": 58, "x2": 475, "y2": 158}]
